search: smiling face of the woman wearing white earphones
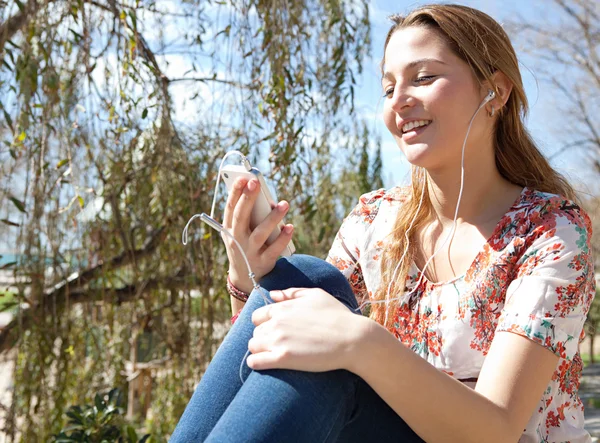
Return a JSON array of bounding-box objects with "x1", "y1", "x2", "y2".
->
[{"x1": 382, "y1": 26, "x2": 493, "y2": 172}]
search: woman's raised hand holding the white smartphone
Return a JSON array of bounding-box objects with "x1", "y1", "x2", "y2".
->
[{"x1": 223, "y1": 178, "x2": 294, "y2": 292}]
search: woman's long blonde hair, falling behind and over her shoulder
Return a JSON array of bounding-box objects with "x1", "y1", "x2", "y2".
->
[{"x1": 370, "y1": 5, "x2": 577, "y2": 328}]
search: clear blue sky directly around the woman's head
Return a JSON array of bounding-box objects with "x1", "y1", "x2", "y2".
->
[{"x1": 357, "y1": 0, "x2": 595, "y2": 192}]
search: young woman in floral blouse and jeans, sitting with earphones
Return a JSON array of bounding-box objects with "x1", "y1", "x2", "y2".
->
[{"x1": 171, "y1": 5, "x2": 595, "y2": 443}]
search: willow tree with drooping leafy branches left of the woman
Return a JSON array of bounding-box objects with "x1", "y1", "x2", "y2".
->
[{"x1": 0, "y1": 0, "x2": 369, "y2": 441}]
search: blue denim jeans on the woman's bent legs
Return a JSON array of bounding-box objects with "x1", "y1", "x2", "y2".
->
[{"x1": 170, "y1": 254, "x2": 423, "y2": 443}]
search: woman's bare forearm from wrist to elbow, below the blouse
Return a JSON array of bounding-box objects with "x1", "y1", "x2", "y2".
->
[{"x1": 351, "y1": 318, "x2": 519, "y2": 443}]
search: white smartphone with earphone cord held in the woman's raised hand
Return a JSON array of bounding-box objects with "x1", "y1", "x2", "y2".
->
[{"x1": 221, "y1": 165, "x2": 296, "y2": 257}]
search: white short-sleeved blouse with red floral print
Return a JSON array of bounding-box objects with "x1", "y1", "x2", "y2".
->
[{"x1": 327, "y1": 187, "x2": 595, "y2": 443}]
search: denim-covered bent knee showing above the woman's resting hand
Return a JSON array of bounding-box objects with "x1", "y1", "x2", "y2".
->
[{"x1": 260, "y1": 254, "x2": 358, "y2": 309}]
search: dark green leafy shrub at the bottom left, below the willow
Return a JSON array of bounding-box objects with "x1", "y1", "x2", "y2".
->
[{"x1": 54, "y1": 388, "x2": 150, "y2": 443}]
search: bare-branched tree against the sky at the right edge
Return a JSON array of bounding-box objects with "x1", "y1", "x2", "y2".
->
[{"x1": 506, "y1": 0, "x2": 600, "y2": 363}]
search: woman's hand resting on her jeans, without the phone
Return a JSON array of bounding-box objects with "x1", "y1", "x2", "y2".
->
[{"x1": 247, "y1": 288, "x2": 370, "y2": 372}]
